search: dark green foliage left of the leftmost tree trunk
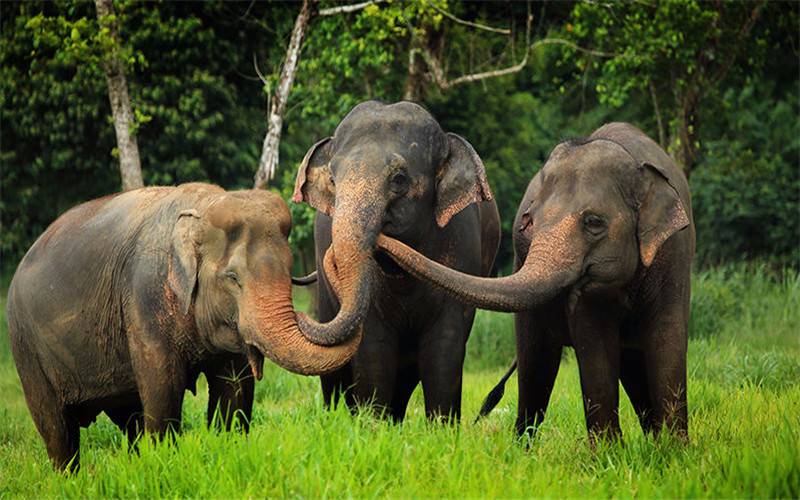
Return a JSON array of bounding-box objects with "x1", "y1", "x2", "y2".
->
[{"x1": 0, "y1": 3, "x2": 119, "y2": 265}]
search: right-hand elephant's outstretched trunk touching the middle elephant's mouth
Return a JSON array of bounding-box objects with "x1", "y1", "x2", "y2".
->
[{"x1": 377, "y1": 217, "x2": 583, "y2": 312}]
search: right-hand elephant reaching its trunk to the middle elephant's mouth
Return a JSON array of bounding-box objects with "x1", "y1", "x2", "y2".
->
[{"x1": 378, "y1": 123, "x2": 695, "y2": 444}]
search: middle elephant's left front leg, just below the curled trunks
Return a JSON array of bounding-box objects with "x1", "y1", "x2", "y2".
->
[{"x1": 348, "y1": 311, "x2": 399, "y2": 417}]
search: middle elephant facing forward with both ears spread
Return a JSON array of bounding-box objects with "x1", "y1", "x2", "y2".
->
[{"x1": 293, "y1": 101, "x2": 500, "y2": 422}]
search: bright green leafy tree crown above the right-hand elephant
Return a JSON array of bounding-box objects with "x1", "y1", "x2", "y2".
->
[{"x1": 564, "y1": 0, "x2": 763, "y2": 146}]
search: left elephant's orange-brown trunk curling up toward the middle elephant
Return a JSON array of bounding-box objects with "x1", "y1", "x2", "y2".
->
[{"x1": 239, "y1": 277, "x2": 362, "y2": 375}]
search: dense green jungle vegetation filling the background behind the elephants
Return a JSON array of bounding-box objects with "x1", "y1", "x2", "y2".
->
[{"x1": 0, "y1": 0, "x2": 800, "y2": 272}]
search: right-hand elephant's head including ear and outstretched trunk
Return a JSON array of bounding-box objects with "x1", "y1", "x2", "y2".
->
[{"x1": 378, "y1": 124, "x2": 691, "y2": 311}]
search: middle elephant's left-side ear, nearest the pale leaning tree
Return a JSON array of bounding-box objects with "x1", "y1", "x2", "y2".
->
[{"x1": 292, "y1": 137, "x2": 336, "y2": 215}]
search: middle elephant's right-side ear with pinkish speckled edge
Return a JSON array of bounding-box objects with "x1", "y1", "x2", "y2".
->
[{"x1": 435, "y1": 133, "x2": 492, "y2": 227}]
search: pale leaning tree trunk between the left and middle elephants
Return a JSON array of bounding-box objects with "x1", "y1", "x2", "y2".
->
[{"x1": 256, "y1": 0, "x2": 317, "y2": 189}]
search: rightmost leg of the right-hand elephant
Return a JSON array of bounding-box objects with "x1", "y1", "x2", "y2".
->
[{"x1": 642, "y1": 306, "x2": 689, "y2": 439}]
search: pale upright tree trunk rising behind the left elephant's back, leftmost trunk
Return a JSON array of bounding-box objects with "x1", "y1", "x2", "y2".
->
[{"x1": 94, "y1": 0, "x2": 144, "y2": 191}]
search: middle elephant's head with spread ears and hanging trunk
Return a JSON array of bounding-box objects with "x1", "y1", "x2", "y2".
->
[{"x1": 293, "y1": 101, "x2": 492, "y2": 337}]
